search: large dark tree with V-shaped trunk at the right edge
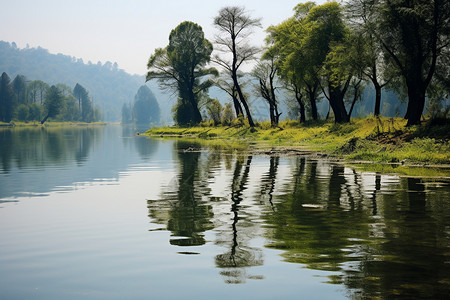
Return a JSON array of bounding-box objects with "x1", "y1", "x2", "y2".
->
[{"x1": 360, "y1": 0, "x2": 450, "y2": 126}]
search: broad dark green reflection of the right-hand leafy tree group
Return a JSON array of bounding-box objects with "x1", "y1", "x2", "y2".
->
[{"x1": 266, "y1": 159, "x2": 450, "y2": 299}]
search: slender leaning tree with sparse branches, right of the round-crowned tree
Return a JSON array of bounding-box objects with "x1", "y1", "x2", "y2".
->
[{"x1": 213, "y1": 6, "x2": 261, "y2": 127}]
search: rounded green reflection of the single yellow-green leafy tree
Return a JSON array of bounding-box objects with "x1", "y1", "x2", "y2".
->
[{"x1": 268, "y1": 162, "x2": 367, "y2": 271}]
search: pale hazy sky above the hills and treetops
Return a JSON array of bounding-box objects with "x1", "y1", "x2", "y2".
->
[{"x1": 0, "y1": 0, "x2": 325, "y2": 75}]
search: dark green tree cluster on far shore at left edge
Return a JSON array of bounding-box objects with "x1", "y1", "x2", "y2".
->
[{"x1": 0, "y1": 72, "x2": 101, "y2": 123}]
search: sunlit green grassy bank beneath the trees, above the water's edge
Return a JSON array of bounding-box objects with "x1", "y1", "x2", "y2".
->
[{"x1": 145, "y1": 117, "x2": 450, "y2": 169}]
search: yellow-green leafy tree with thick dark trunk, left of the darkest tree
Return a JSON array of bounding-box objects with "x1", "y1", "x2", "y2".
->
[{"x1": 289, "y1": 2, "x2": 353, "y2": 123}]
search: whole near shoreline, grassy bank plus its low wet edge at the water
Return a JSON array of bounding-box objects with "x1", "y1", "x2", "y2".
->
[{"x1": 142, "y1": 117, "x2": 450, "y2": 177}]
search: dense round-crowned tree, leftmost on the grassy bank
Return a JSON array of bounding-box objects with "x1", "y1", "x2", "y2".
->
[{"x1": 146, "y1": 21, "x2": 217, "y2": 125}]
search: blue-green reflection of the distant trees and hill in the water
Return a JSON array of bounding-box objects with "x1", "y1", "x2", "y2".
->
[{"x1": 0, "y1": 126, "x2": 159, "y2": 202}]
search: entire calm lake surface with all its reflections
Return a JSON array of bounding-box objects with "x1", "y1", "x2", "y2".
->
[{"x1": 0, "y1": 125, "x2": 450, "y2": 300}]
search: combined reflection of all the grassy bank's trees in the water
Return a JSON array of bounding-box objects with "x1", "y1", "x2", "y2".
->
[{"x1": 148, "y1": 148, "x2": 450, "y2": 299}]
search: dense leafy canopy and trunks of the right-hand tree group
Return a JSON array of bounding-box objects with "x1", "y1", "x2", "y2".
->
[{"x1": 266, "y1": 0, "x2": 450, "y2": 126}]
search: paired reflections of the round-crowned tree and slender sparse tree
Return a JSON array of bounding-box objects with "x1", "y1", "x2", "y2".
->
[{"x1": 148, "y1": 149, "x2": 263, "y2": 283}]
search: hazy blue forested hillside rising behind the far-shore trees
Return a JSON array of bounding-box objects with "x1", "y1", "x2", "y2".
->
[{"x1": 0, "y1": 41, "x2": 170, "y2": 122}]
